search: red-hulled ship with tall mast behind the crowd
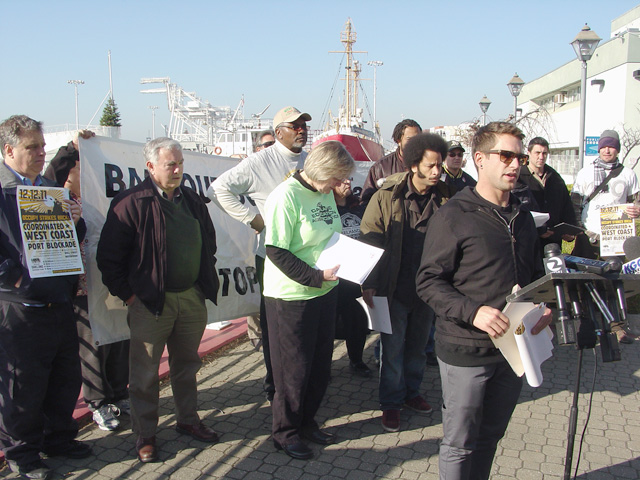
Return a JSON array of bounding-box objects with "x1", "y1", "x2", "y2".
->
[{"x1": 312, "y1": 18, "x2": 384, "y2": 162}]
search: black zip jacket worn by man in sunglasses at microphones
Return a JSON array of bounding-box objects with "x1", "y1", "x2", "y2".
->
[{"x1": 416, "y1": 188, "x2": 544, "y2": 365}]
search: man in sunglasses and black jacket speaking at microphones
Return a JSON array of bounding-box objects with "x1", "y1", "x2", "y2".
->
[{"x1": 416, "y1": 122, "x2": 551, "y2": 480}]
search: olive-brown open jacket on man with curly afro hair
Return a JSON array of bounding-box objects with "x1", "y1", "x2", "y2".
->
[{"x1": 360, "y1": 173, "x2": 453, "y2": 299}]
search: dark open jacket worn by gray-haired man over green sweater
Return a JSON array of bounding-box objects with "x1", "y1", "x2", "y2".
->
[{"x1": 96, "y1": 177, "x2": 220, "y2": 315}]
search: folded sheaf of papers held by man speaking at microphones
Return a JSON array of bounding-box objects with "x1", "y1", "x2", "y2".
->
[{"x1": 491, "y1": 302, "x2": 553, "y2": 387}]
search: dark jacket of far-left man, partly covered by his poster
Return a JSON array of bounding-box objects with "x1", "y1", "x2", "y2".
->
[{"x1": 0, "y1": 162, "x2": 87, "y2": 303}]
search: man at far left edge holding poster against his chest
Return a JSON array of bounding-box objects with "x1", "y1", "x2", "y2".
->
[{"x1": 0, "y1": 115, "x2": 91, "y2": 478}]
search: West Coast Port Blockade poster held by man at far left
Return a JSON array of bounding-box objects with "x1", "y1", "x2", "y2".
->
[{"x1": 16, "y1": 185, "x2": 84, "y2": 278}]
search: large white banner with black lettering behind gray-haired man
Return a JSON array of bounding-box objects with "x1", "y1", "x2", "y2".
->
[{"x1": 79, "y1": 137, "x2": 260, "y2": 344}]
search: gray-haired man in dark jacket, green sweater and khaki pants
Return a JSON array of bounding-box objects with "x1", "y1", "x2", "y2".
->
[{"x1": 96, "y1": 138, "x2": 219, "y2": 463}]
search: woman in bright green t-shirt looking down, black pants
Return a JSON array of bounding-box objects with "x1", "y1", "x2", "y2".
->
[{"x1": 264, "y1": 141, "x2": 355, "y2": 460}]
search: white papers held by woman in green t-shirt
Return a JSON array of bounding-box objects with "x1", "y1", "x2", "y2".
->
[{"x1": 316, "y1": 233, "x2": 384, "y2": 285}]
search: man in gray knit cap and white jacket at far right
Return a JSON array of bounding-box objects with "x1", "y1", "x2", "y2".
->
[{"x1": 571, "y1": 130, "x2": 640, "y2": 343}]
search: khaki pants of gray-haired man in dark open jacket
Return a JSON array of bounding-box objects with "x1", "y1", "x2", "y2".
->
[{"x1": 127, "y1": 287, "x2": 207, "y2": 437}]
